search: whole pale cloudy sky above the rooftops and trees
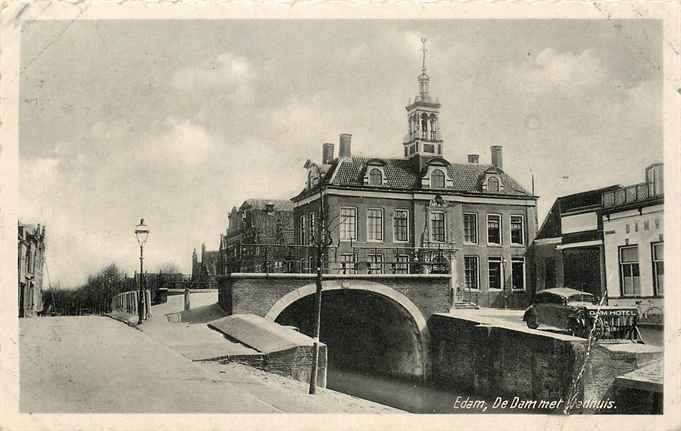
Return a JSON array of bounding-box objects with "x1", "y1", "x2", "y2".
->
[{"x1": 19, "y1": 20, "x2": 663, "y2": 287}]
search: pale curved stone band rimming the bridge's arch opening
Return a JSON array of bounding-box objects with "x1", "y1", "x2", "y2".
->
[{"x1": 265, "y1": 280, "x2": 430, "y2": 379}]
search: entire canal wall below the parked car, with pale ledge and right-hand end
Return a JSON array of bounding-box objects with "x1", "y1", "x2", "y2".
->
[{"x1": 428, "y1": 314, "x2": 662, "y2": 413}]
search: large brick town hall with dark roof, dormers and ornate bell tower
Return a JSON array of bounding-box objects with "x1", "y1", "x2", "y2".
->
[{"x1": 291, "y1": 40, "x2": 537, "y2": 307}]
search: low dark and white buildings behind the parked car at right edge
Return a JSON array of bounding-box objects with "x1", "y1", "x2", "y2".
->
[{"x1": 532, "y1": 163, "x2": 664, "y2": 317}]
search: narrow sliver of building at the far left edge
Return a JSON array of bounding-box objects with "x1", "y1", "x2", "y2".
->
[{"x1": 17, "y1": 223, "x2": 46, "y2": 317}]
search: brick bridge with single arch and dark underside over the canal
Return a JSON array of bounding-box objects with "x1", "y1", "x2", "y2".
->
[{"x1": 218, "y1": 273, "x2": 453, "y2": 379}]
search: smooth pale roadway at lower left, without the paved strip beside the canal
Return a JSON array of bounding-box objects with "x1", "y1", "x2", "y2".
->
[{"x1": 19, "y1": 316, "x2": 279, "y2": 413}]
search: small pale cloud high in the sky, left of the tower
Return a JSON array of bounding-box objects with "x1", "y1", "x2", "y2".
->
[{"x1": 171, "y1": 53, "x2": 256, "y2": 102}]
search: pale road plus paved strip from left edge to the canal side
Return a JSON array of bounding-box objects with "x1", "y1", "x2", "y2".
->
[{"x1": 19, "y1": 316, "x2": 395, "y2": 413}]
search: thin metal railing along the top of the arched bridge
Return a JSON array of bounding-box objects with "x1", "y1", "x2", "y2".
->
[{"x1": 224, "y1": 244, "x2": 455, "y2": 274}]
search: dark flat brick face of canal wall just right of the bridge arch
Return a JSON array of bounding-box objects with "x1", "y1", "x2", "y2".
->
[{"x1": 428, "y1": 315, "x2": 585, "y2": 400}]
